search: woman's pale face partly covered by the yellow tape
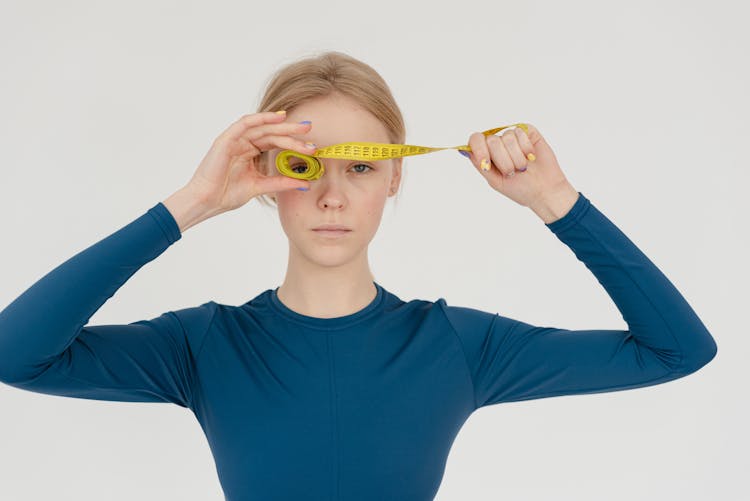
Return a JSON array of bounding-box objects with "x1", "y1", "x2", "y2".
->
[{"x1": 268, "y1": 94, "x2": 402, "y2": 267}]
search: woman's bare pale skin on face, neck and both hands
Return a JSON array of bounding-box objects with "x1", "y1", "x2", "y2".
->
[{"x1": 163, "y1": 94, "x2": 578, "y2": 318}]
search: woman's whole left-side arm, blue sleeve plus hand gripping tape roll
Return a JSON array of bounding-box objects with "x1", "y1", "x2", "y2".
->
[{"x1": 0, "y1": 112, "x2": 318, "y2": 407}]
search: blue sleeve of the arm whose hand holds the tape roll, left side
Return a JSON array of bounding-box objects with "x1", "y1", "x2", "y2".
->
[{"x1": 0, "y1": 202, "x2": 216, "y2": 407}]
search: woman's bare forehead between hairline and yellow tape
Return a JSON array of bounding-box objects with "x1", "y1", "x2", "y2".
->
[{"x1": 280, "y1": 95, "x2": 391, "y2": 148}]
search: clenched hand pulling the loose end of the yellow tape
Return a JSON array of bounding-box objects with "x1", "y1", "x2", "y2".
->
[{"x1": 463, "y1": 124, "x2": 571, "y2": 208}]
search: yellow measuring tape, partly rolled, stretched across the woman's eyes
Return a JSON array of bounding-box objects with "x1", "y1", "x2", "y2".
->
[{"x1": 276, "y1": 123, "x2": 529, "y2": 181}]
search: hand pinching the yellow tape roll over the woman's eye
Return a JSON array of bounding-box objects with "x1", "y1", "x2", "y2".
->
[{"x1": 186, "y1": 111, "x2": 315, "y2": 213}]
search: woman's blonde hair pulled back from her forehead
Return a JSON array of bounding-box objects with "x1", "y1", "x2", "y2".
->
[{"x1": 256, "y1": 51, "x2": 406, "y2": 207}]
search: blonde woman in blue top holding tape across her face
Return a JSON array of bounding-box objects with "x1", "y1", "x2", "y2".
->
[{"x1": 0, "y1": 52, "x2": 716, "y2": 501}]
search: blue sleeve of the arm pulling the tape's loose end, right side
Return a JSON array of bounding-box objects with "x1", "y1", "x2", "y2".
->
[{"x1": 438, "y1": 192, "x2": 717, "y2": 408}]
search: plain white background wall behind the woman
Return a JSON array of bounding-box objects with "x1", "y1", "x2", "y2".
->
[{"x1": 0, "y1": 0, "x2": 750, "y2": 501}]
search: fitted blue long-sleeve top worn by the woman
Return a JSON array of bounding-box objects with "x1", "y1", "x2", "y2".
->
[{"x1": 0, "y1": 192, "x2": 717, "y2": 501}]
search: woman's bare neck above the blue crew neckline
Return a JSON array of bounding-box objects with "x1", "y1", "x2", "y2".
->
[{"x1": 277, "y1": 246, "x2": 377, "y2": 318}]
